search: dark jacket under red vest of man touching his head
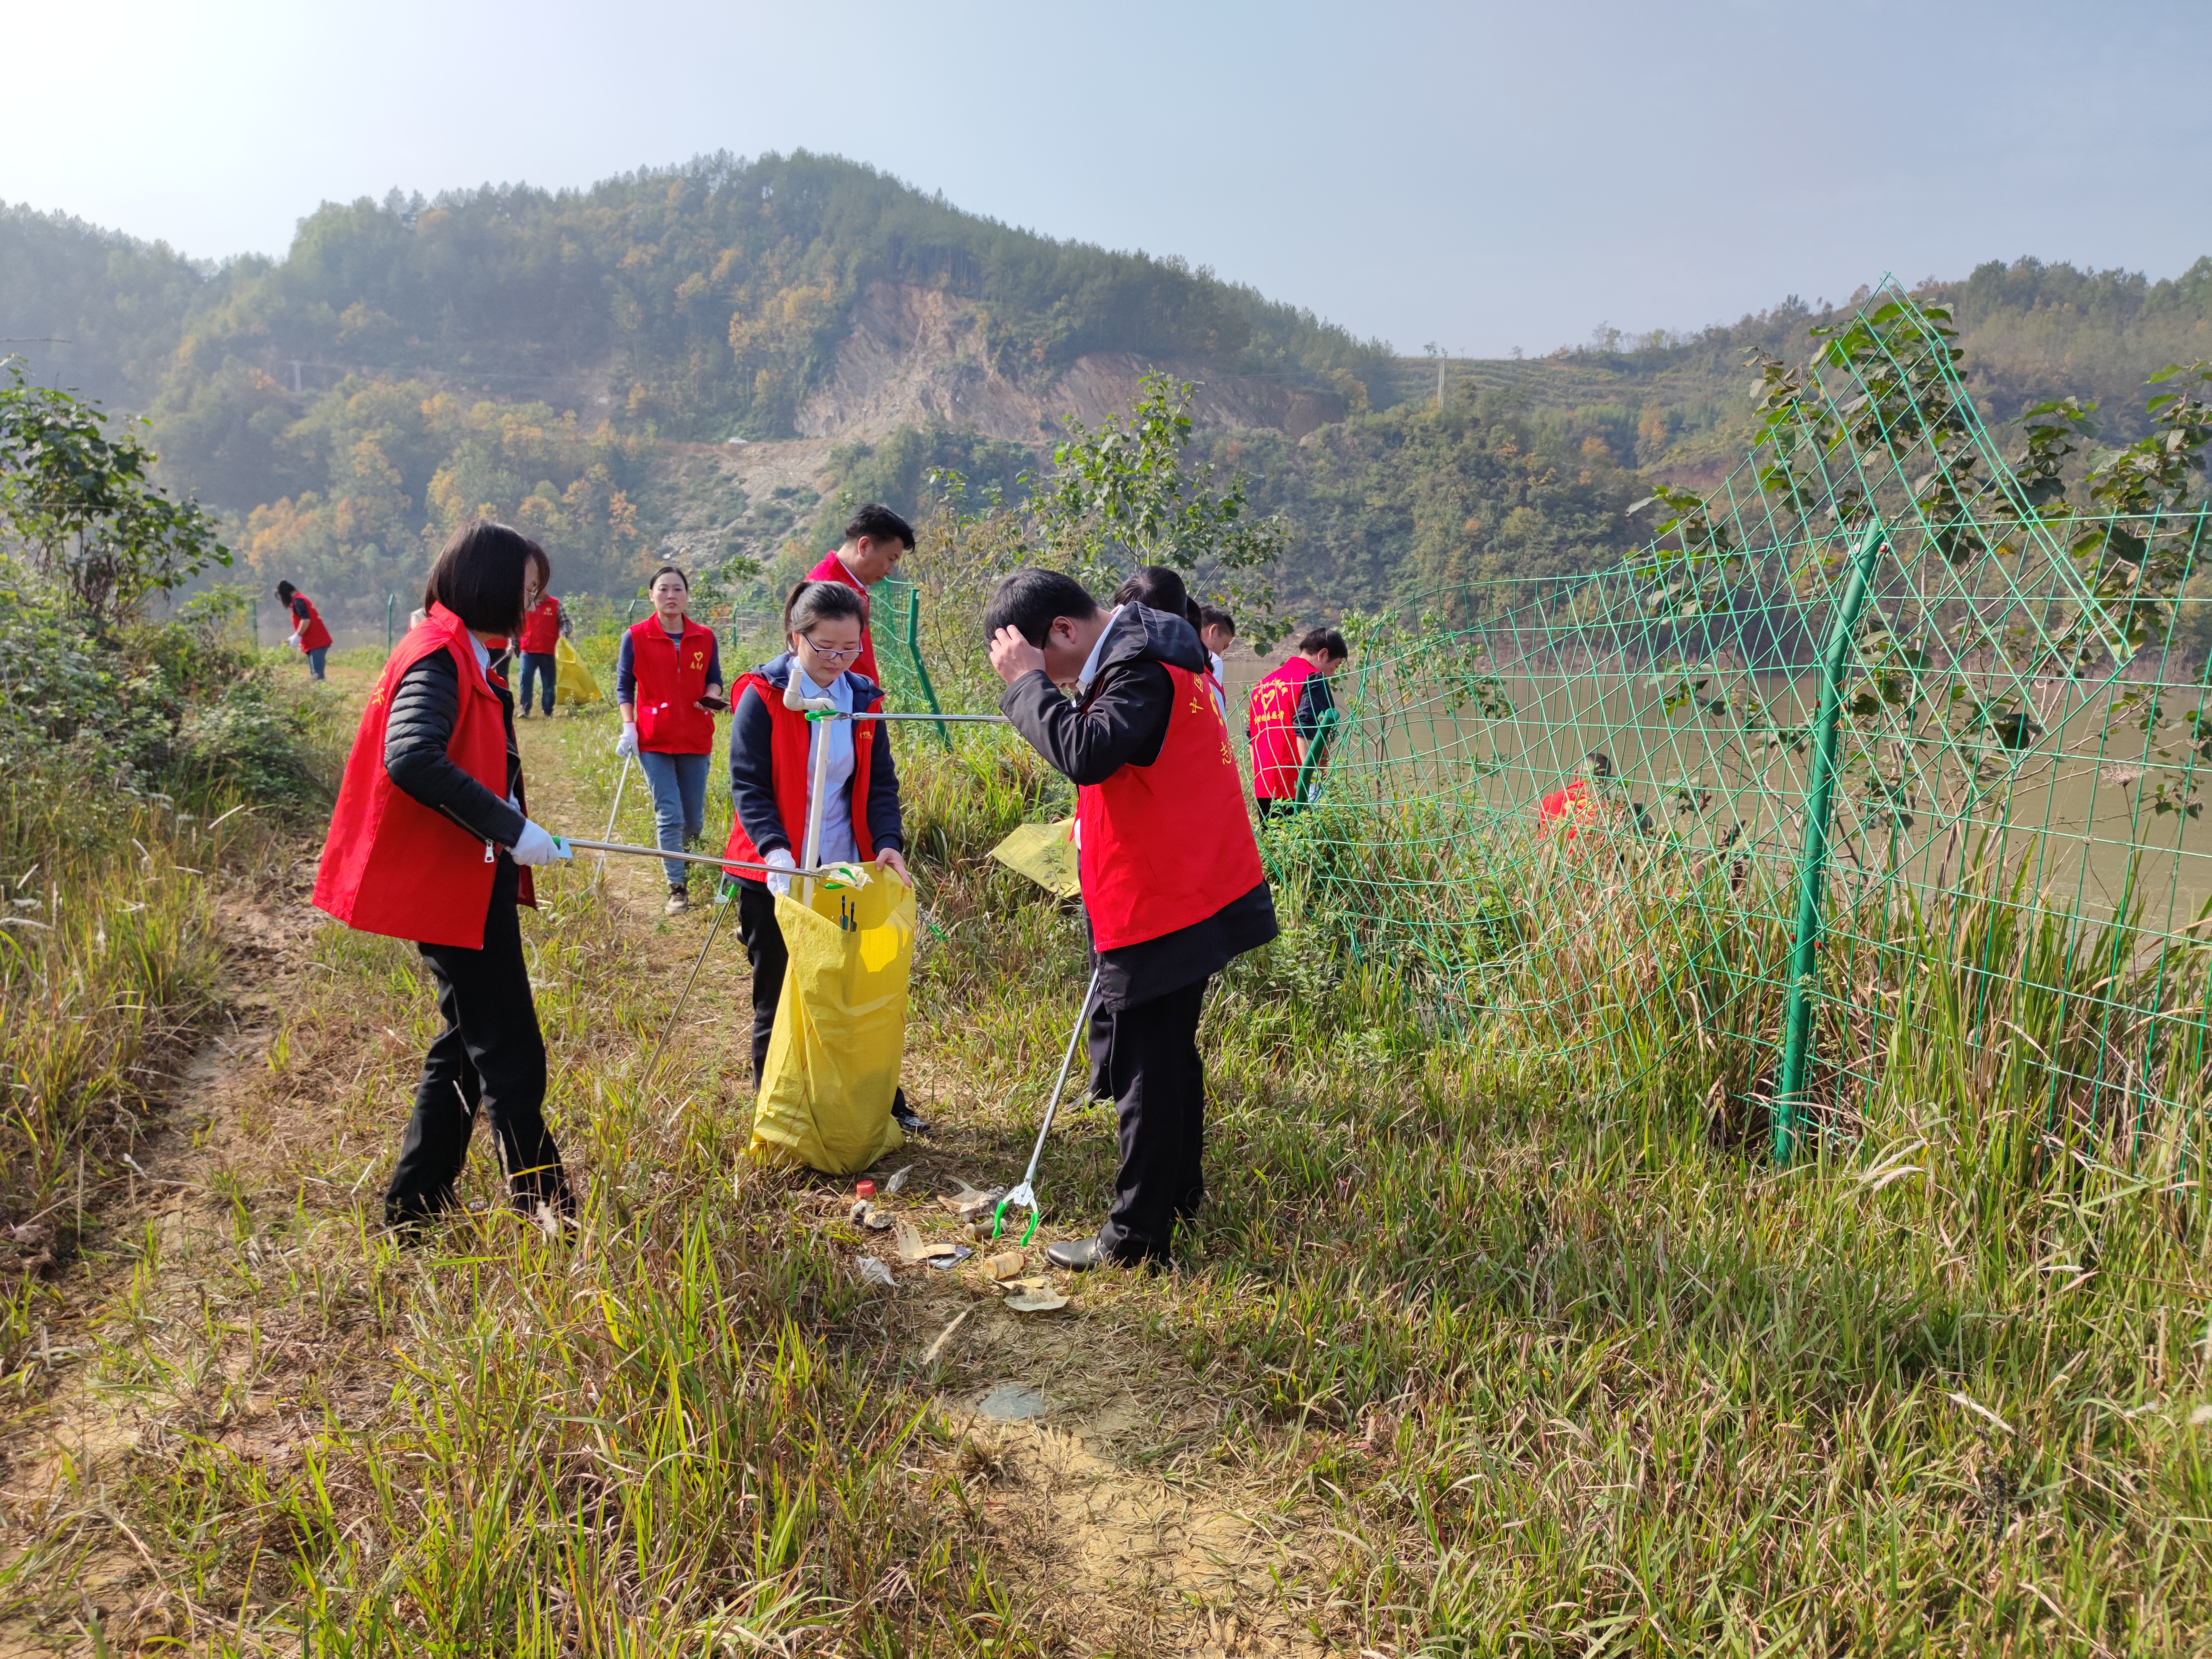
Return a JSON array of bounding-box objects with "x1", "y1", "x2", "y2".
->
[{"x1": 998, "y1": 604, "x2": 1281, "y2": 1009}]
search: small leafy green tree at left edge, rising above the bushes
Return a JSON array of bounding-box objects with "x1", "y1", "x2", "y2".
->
[{"x1": 0, "y1": 356, "x2": 230, "y2": 628}]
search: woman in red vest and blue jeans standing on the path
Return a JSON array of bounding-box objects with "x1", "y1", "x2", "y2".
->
[{"x1": 615, "y1": 564, "x2": 726, "y2": 916}]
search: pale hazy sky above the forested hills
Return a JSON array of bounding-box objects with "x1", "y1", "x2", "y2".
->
[{"x1": 0, "y1": 0, "x2": 2212, "y2": 356}]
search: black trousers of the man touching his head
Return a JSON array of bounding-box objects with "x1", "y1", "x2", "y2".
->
[{"x1": 1100, "y1": 980, "x2": 1208, "y2": 1261}]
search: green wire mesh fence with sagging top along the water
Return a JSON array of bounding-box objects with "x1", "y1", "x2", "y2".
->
[{"x1": 1268, "y1": 288, "x2": 2212, "y2": 1157}]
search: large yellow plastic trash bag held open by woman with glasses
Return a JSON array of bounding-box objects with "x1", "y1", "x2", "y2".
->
[{"x1": 750, "y1": 865, "x2": 914, "y2": 1175}]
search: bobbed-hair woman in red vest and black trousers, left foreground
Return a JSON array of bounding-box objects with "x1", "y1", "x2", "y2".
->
[{"x1": 314, "y1": 520, "x2": 575, "y2": 1228}]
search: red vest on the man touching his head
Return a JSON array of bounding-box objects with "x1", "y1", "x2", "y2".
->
[{"x1": 1075, "y1": 664, "x2": 1263, "y2": 951}]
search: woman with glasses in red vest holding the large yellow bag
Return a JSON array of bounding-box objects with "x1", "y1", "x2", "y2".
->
[{"x1": 726, "y1": 582, "x2": 920, "y2": 1130}]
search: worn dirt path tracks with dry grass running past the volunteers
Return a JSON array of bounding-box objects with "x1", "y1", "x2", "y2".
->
[{"x1": 0, "y1": 703, "x2": 1329, "y2": 1657}]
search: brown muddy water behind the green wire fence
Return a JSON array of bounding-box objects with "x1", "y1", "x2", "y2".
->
[{"x1": 1230, "y1": 664, "x2": 2212, "y2": 931}]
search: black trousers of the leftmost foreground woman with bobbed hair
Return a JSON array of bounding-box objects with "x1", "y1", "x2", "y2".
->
[{"x1": 385, "y1": 858, "x2": 575, "y2": 1228}]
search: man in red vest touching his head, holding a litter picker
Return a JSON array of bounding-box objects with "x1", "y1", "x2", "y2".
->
[{"x1": 984, "y1": 571, "x2": 1276, "y2": 1272}]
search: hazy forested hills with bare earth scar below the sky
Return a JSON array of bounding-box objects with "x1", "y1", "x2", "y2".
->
[{"x1": 0, "y1": 153, "x2": 2212, "y2": 626}]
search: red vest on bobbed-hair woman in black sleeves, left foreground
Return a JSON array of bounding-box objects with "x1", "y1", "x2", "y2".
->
[{"x1": 314, "y1": 604, "x2": 535, "y2": 951}]
